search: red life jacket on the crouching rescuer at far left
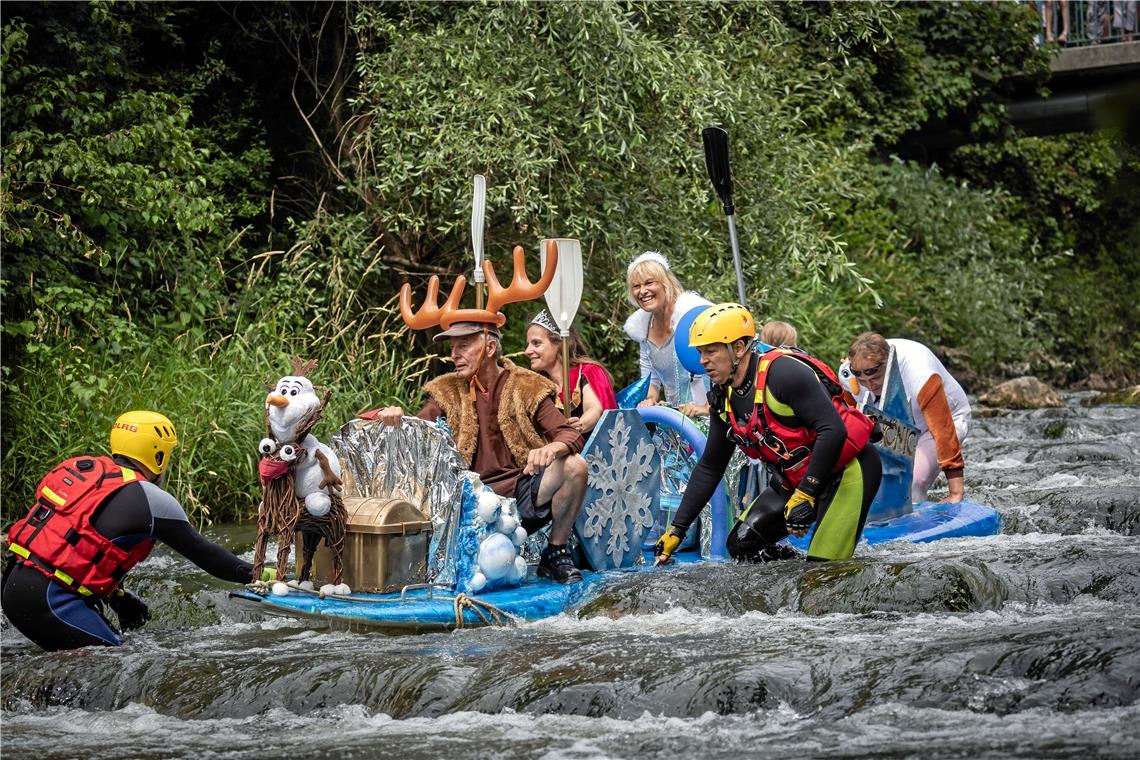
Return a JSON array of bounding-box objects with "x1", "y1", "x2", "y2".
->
[{"x1": 8, "y1": 457, "x2": 154, "y2": 596}]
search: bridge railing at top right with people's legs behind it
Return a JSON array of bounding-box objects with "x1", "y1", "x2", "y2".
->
[{"x1": 1034, "y1": 0, "x2": 1140, "y2": 48}]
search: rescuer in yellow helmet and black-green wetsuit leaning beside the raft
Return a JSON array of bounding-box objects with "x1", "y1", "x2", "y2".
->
[{"x1": 654, "y1": 303, "x2": 882, "y2": 564}]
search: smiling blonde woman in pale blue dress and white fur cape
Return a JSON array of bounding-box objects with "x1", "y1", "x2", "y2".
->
[{"x1": 625, "y1": 251, "x2": 713, "y2": 416}]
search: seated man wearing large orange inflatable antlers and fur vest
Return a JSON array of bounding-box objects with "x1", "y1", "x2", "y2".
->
[{"x1": 360, "y1": 247, "x2": 587, "y2": 583}]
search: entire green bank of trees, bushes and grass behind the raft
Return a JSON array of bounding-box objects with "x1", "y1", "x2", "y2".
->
[{"x1": 0, "y1": 2, "x2": 1140, "y2": 520}]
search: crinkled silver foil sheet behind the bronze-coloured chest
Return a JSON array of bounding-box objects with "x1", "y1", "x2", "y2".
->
[{"x1": 333, "y1": 417, "x2": 467, "y2": 583}]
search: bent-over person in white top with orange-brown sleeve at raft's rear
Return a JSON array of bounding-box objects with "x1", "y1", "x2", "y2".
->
[{"x1": 847, "y1": 333, "x2": 970, "y2": 504}]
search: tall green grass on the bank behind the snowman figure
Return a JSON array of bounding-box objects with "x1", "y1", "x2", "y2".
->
[{"x1": 2, "y1": 288, "x2": 429, "y2": 521}]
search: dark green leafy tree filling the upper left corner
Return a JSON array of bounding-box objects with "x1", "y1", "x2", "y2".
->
[{"x1": 0, "y1": 3, "x2": 267, "y2": 350}]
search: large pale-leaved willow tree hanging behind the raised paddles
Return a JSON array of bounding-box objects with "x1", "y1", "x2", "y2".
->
[{"x1": 312, "y1": 3, "x2": 879, "y2": 369}]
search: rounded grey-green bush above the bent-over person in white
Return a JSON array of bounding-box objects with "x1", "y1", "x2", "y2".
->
[{"x1": 825, "y1": 160, "x2": 1056, "y2": 387}]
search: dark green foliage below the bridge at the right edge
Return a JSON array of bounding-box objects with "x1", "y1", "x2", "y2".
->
[{"x1": 948, "y1": 133, "x2": 1140, "y2": 383}]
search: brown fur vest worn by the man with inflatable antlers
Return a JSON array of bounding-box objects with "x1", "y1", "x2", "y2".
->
[{"x1": 424, "y1": 359, "x2": 557, "y2": 467}]
